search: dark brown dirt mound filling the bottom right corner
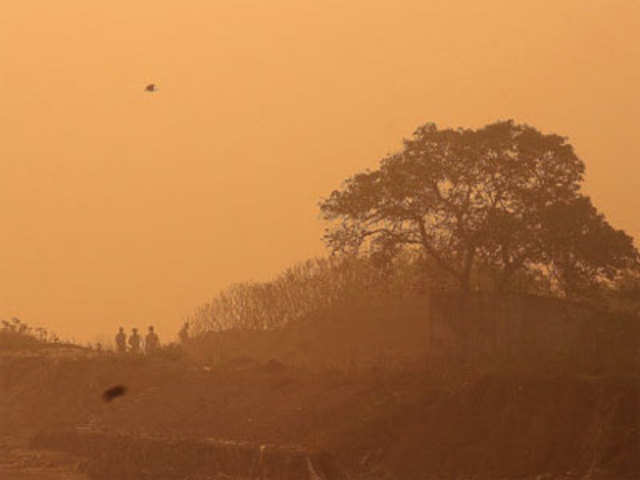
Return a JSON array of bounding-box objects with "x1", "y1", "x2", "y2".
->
[{"x1": 336, "y1": 376, "x2": 640, "y2": 480}]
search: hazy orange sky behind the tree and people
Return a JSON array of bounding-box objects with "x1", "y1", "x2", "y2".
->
[{"x1": 0, "y1": 0, "x2": 640, "y2": 341}]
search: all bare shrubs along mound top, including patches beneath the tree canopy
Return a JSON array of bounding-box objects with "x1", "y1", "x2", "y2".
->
[{"x1": 187, "y1": 250, "x2": 640, "y2": 336}]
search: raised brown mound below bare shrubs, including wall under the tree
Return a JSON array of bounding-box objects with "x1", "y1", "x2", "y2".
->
[{"x1": 189, "y1": 294, "x2": 640, "y2": 374}]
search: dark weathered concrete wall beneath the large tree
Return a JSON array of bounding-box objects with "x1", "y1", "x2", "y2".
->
[{"x1": 428, "y1": 294, "x2": 640, "y2": 368}]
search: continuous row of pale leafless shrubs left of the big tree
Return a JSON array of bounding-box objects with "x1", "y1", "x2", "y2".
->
[{"x1": 188, "y1": 254, "x2": 428, "y2": 335}]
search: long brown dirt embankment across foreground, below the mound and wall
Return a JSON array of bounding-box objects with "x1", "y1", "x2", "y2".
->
[{"x1": 0, "y1": 348, "x2": 640, "y2": 479}]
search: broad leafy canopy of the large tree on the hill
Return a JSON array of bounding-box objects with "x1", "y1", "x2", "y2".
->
[{"x1": 320, "y1": 120, "x2": 638, "y2": 294}]
